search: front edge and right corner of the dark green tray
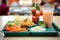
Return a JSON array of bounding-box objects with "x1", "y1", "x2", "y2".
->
[{"x1": 4, "y1": 23, "x2": 58, "y2": 36}]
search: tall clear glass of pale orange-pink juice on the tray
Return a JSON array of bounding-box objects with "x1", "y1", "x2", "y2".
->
[{"x1": 42, "y1": 8, "x2": 54, "y2": 27}]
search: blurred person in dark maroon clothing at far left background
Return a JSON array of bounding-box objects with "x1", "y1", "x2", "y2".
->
[{"x1": 0, "y1": 0, "x2": 9, "y2": 16}]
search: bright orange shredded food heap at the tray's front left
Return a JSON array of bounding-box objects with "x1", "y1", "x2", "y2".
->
[{"x1": 5, "y1": 24, "x2": 27, "y2": 32}]
